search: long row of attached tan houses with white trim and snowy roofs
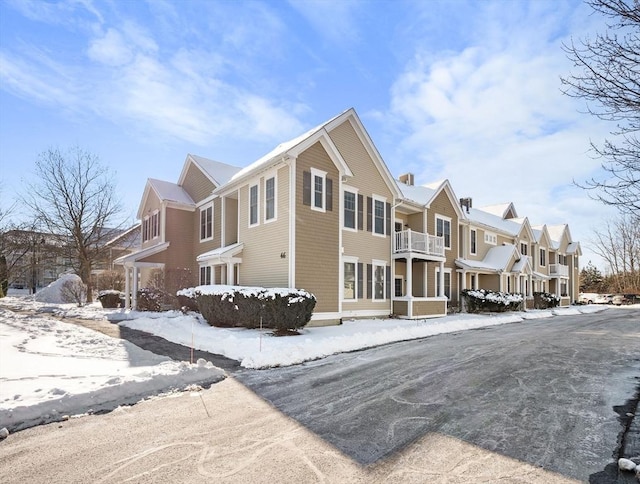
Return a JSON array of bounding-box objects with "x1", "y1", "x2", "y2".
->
[{"x1": 116, "y1": 109, "x2": 580, "y2": 324}]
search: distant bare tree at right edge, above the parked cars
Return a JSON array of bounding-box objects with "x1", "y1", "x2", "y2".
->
[{"x1": 591, "y1": 215, "x2": 640, "y2": 292}]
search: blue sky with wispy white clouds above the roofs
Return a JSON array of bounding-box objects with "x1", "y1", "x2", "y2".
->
[{"x1": 0, "y1": 0, "x2": 614, "y2": 269}]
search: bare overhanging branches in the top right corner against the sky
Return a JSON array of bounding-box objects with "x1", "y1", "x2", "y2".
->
[{"x1": 561, "y1": 0, "x2": 640, "y2": 213}]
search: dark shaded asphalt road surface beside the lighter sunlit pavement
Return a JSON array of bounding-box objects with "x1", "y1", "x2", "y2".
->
[{"x1": 234, "y1": 309, "x2": 640, "y2": 482}]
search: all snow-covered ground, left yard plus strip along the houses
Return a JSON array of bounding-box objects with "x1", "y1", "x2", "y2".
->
[{"x1": 0, "y1": 296, "x2": 607, "y2": 430}]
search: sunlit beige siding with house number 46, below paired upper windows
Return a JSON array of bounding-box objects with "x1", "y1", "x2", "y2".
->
[{"x1": 238, "y1": 167, "x2": 290, "y2": 287}]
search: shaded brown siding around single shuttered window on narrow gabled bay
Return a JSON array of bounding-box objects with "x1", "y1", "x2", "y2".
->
[{"x1": 295, "y1": 143, "x2": 342, "y2": 312}]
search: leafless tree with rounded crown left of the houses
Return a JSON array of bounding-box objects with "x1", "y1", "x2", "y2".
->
[{"x1": 22, "y1": 147, "x2": 121, "y2": 301}]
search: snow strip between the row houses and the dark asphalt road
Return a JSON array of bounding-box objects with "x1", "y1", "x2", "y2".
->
[{"x1": 119, "y1": 306, "x2": 607, "y2": 369}]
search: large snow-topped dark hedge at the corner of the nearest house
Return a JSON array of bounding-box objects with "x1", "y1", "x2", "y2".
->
[{"x1": 178, "y1": 286, "x2": 316, "y2": 334}]
